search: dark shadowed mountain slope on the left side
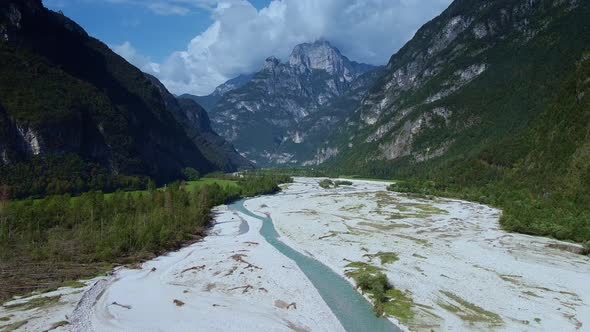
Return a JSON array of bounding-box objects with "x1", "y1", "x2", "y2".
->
[{"x1": 0, "y1": 0, "x2": 243, "y2": 196}]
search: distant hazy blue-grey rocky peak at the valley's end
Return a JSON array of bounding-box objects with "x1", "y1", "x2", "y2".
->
[{"x1": 202, "y1": 41, "x2": 376, "y2": 166}]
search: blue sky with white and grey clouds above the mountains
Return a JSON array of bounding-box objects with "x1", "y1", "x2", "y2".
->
[{"x1": 43, "y1": 0, "x2": 451, "y2": 95}]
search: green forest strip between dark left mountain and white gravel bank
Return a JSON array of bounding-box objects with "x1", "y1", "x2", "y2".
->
[{"x1": 0, "y1": 173, "x2": 291, "y2": 300}]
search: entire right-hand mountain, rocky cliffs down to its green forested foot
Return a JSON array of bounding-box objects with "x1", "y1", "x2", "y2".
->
[{"x1": 326, "y1": 0, "x2": 590, "y2": 241}]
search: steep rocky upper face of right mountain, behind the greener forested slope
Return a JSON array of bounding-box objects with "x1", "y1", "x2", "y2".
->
[{"x1": 327, "y1": 0, "x2": 590, "y2": 172}]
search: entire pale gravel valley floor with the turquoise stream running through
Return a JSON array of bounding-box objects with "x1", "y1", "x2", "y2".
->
[{"x1": 0, "y1": 178, "x2": 590, "y2": 331}]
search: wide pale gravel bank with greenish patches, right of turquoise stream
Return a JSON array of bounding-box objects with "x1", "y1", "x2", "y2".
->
[{"x1": 246, "y1": 178, "x2": 590, "y2": 331}]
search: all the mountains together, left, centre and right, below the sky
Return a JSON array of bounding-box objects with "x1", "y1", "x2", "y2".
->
[{"x1": 0, "y1": 0, "x2": 590, "y2": 244}]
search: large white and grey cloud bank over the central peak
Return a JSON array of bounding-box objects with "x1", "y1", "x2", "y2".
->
[{"x1": 118, "y1": 0, "x2": 451, "y2": 95}]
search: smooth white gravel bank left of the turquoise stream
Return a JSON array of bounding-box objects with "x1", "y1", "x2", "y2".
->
[{"x1": 0, "y1": 207, "x2": 343, "y2": 331}]
